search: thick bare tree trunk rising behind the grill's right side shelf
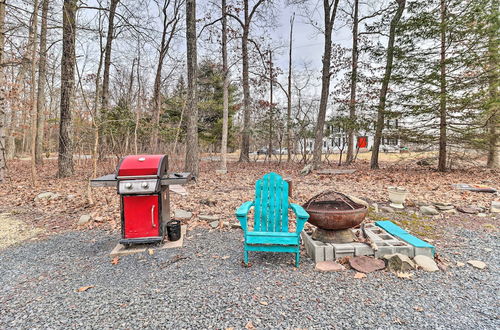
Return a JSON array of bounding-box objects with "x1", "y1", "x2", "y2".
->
[{"x1": 184, "y1": 0, "x2": 199, "y2": 176}]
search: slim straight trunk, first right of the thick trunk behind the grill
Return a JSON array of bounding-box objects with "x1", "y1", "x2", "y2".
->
[{"x1": 220, "y1": 0, "x2": 229, "y2": 173}]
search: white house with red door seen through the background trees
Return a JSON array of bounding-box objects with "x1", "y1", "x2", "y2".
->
[{"x1": 297, "y1": 119, "x2": 403, "y2": 154}]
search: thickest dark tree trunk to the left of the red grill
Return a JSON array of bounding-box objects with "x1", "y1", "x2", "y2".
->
[{"x1": 58, "y1": 0, "x2": 77, "y2": 177}]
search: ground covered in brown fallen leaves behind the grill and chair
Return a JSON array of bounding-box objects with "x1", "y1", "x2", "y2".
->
[{"x1": 0, "y1": 155, "x2": 500, "y2": 242}]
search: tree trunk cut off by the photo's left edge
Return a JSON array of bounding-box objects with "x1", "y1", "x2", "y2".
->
[{"x1": 0, "y1": 0, "x2": 7, "y2": 183}]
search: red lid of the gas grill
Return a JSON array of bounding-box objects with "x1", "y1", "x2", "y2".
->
[{"x1": 117, "y1": 155, "x2": 168, "y2": 178}]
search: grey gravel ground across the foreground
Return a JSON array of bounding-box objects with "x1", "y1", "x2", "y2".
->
[{"x1": 0, "y1": 228, "x2": 500, "y2": 329}]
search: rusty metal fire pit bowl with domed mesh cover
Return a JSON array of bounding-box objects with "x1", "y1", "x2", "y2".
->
[{"x1": 303, "y1": 191, "x2": 368, "y2": 243}]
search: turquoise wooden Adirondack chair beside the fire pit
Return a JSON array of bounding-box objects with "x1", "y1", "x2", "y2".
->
[{"x1": 236, "y1": 172, "x2": 309, "y2": 267}]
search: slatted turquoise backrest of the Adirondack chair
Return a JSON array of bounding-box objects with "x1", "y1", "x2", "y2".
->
[{"x1": 254, "y1": 172, "x2": 288, "y2": 232}]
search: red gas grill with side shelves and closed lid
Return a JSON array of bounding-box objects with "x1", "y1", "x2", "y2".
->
[{"x1": 91, "y1": 155, "x2": 190, "y2": 245}]
